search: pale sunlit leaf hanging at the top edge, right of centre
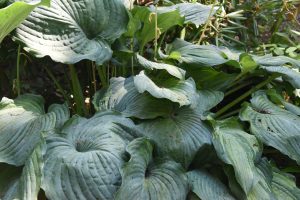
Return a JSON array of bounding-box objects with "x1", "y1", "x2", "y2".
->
[{"x1": 158, "y1": 3, "x2": 216, "y2": 27}]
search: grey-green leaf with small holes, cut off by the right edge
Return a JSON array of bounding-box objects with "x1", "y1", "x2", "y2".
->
[{"x1": 240, "y1": 91, "x2": 300, "y2": 163}]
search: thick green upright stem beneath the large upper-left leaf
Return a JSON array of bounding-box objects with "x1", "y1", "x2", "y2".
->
[{"x1": 69, "y1": 65, "x2": 88, "y2": 116}]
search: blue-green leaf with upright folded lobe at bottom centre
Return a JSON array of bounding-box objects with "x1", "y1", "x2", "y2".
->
[{"x1": 116, "y1": 138, "x2": 188, "y2": 200}]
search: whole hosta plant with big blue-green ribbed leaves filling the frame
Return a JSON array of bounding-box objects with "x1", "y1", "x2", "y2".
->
[{"x1": 0, "y1": 0, "x2": 300, "y2": 200}]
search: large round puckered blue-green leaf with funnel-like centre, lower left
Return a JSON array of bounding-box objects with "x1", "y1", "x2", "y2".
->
[{"x1": 42, "y1": 113, "x2": 135, "y2": 200}]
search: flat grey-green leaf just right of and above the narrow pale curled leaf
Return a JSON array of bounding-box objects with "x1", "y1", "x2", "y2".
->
[{"x1": 166, "y1": 39, "x2": 229, "y2": 66}]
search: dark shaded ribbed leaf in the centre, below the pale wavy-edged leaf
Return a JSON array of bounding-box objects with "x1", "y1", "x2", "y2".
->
[{"x1": 139, "y1": 107, "x2": 211, "y2": 167}]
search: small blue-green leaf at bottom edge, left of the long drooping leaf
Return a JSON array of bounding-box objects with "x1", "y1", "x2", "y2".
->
[{"x1": 187, "y1": 170, "x2": 235, "y2": 200}]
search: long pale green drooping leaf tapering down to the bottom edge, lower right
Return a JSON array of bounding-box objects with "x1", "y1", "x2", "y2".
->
[{"x1": 212, "y1": 119, "x2": 273, "y2": 199}]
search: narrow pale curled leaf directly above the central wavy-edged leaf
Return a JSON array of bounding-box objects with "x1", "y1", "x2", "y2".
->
[{"x1": 137, "y1": 55, "x2": 185, "y2": 80}]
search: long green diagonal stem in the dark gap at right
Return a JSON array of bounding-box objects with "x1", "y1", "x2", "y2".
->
[{"x1": 215, "y1": 74, "x2": 279, "y2": 118}]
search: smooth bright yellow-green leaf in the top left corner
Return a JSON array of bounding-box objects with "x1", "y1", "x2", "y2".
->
[{"x1": 0, "y1": 0, "x2": 50, "y2": 43}]
